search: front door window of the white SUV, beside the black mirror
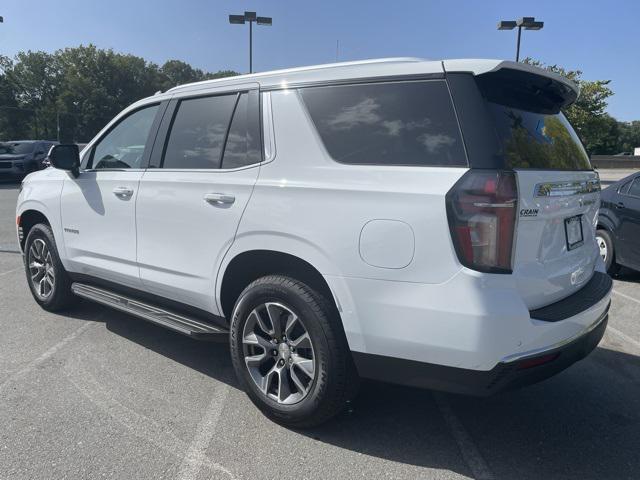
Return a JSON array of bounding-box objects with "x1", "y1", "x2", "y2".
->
[{"x1": 87, "y1": 105, "x2": 159, "y2": 170}]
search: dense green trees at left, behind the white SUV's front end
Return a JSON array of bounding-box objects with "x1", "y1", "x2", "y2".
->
[{"x1": 0, "y1": 45, "x2": 237, "y2": 142}]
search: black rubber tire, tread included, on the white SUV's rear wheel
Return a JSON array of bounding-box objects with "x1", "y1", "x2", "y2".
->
[{"x1": 230, "y1": 275, "x2": 359, "y2": 428}]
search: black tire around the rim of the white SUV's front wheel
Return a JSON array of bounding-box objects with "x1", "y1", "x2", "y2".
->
[{"x1": 24, "y1": 223, "x2": 77, "y2": 312}]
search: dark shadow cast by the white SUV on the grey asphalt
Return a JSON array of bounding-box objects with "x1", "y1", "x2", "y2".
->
[{"x1": 62, "y1": 298, "x2": 640, "y2": 479}]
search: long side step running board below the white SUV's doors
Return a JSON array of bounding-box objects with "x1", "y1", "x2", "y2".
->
[{"x1": 71, "y1": 283, "x2": 229, "y2": 342}]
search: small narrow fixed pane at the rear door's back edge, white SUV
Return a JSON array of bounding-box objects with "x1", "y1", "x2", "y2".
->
[{"x1": 222, "y1": 91, "x2": 262, "y2": 168}]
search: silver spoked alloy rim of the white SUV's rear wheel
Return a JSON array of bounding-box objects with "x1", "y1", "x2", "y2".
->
[{"x1": 242, "y1": 302, "x2": 316, "y2": 404}]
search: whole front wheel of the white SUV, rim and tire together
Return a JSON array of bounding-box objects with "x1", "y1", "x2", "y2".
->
[{"x1": 24, "y1": 223, "x2": 76, "y2": 312}]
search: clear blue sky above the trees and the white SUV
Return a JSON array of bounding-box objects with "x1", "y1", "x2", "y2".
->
[{"x1": 0, "y1": 0, "x2": 640, "y2": 120}]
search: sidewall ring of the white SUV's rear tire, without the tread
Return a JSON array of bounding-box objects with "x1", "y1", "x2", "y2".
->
[{"x1": 230, "y1": 282, "x2": 332, "y2": 419}]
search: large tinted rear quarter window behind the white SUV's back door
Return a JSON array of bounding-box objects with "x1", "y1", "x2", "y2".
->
[{"x1": 300, "y1": 80, "x2": 467, "y2": 166}]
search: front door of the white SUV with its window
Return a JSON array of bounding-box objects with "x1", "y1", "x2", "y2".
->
[{"x1": 61, "y1": 105, "x2": 159, "y2": 287}]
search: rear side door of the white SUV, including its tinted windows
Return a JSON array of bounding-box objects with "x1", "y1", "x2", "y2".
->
[{"x1": 137, "y1": 84, "x2": 262, "y2": 313}]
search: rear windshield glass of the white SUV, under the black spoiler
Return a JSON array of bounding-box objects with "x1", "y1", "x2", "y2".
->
[{"x1": 487, "y1": 102, "x2": 591, "y2": 170}]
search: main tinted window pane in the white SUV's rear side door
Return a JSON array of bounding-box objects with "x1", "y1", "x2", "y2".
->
[{"x1": 162, "y1": 93, "x2": 238, "y2": 169}]
